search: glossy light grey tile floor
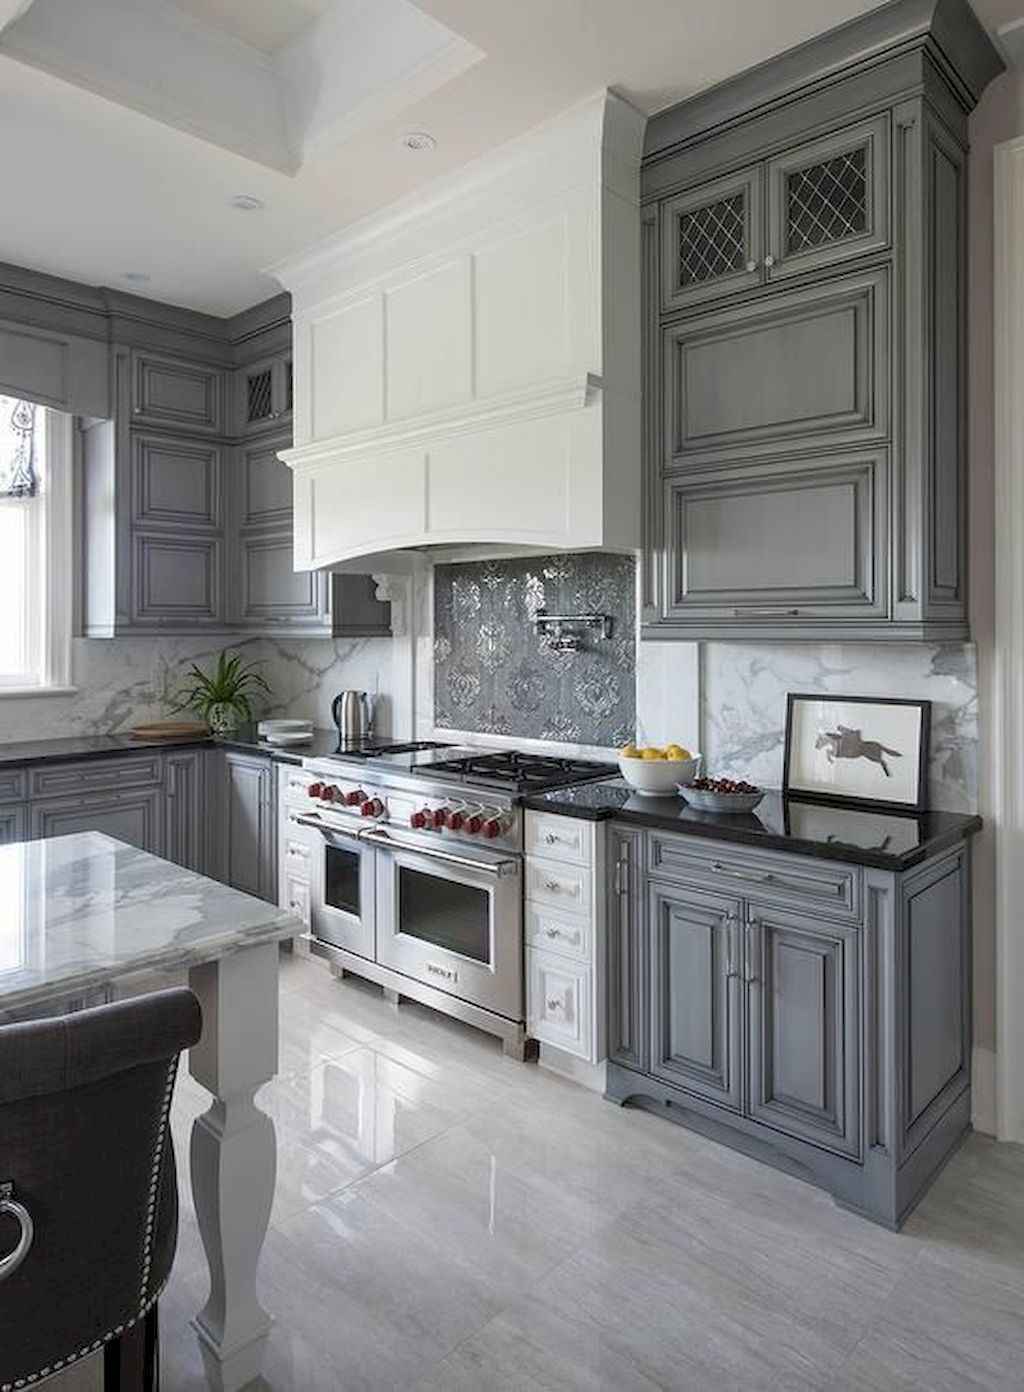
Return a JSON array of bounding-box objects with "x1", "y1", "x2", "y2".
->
[{"x1": 54, "y1": 956, "x2": 1024, "y2": 1392}]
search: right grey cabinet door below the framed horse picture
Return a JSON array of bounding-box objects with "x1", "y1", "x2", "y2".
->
[{"x1": 743, "y1": 905, "x2": 861, "y2": 1157}]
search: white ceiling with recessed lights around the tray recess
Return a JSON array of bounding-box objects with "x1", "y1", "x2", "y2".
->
[{"x1": 0, "y1": 0, "x2": 1024, "y2": 313}]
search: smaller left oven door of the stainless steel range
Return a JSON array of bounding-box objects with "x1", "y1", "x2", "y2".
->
[{"x1": 302, "y1": 817, "x2": 377, "y2": 962}]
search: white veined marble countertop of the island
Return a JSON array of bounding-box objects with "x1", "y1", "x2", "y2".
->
[{"x1": 0, "y1": 831, "x2": 303, "y2": 1020}]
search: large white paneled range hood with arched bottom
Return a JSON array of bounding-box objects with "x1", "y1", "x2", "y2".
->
[{"x1": 274, "y1": 92, "x2": 644, "y2": 569}]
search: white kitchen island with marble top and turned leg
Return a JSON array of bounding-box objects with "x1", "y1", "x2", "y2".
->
[{"x1": 0, "y1": 832, "x2": 301, "y2": 1392}]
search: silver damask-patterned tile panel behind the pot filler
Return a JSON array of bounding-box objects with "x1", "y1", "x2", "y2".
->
[{"x1": 434, "y1": 553, "x2": 636, "y2": 746}]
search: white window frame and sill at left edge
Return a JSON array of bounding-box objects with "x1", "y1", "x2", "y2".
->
[{"x1": 0, "y1": 409, "x2": 75, "y2": 700}]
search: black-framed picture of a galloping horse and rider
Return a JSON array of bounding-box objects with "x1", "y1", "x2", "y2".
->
[{"x1": 782, "y1": 692, "x2": 932, "y2": 812}]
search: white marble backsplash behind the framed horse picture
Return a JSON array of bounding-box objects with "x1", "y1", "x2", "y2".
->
[{"x1": 700, "y1": 643, "x2": 978, "y2": 812}]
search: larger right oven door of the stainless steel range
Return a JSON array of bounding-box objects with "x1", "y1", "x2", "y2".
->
[{"x1": 374, "y1": 834, "x2": 523, "y2": 1020}]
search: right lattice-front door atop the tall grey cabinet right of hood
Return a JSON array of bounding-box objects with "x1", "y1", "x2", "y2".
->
[{"x1": 767, "y1": 116, "x2": 889, "y2": 280}]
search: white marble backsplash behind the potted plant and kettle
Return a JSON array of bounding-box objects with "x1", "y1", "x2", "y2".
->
[{"x1": 0, "y1": 638, "x2": 392, "y2": 743}]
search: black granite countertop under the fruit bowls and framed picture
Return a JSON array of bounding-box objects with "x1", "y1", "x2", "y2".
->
[{"x1": 526, "y1": 778, "x2": 981, "y2": 870}]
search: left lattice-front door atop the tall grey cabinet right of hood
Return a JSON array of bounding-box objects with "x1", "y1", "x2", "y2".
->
[{"x1": 661, "y1": 164, "x2": 764, "y2": 310}]
